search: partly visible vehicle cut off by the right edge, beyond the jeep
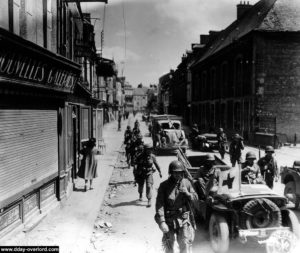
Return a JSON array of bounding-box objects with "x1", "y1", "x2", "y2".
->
[{"x1": 280, "y1": 161, "x2": 300, "y2": 209}]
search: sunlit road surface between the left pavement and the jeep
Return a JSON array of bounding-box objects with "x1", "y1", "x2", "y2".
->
[{"x1": 88, "y1": 114, "x2": 299, "y2": 253}]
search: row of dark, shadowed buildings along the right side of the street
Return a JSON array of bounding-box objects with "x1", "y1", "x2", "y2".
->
[{"x1": 158, "y1": 0, "x2": 300, "y2": 146}]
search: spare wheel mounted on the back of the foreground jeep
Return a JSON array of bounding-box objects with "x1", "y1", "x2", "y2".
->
[{"x1": 241, "y1": 198, "x2": 282, "y2": 229}]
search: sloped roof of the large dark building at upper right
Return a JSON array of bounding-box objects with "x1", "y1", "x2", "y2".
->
[{"x1": 193, "y1": 0, "x2": 300, "y2": 66}]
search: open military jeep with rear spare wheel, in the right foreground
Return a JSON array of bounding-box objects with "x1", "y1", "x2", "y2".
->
[{"x1": 178, "y1": 150, "x2": 300, "y2": 253}]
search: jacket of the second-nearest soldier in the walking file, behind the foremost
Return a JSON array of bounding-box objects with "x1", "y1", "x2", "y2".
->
[{"x1": 136, "y1": 152, "x2": 161, "y2": 176}]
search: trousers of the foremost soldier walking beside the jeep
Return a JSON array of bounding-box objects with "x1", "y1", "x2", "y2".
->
[{"x1": 162, "y1": 222, "x2": 195, "y2": 253}]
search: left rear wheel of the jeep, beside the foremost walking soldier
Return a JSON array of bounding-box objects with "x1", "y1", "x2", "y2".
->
[{"x1": 209, "y1": 214, "x2": 229, "y2": 253}]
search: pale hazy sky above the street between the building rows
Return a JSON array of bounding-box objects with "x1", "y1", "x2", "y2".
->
[{"x1": 81, "y1": 0, "x2": 257, "y2": 87}]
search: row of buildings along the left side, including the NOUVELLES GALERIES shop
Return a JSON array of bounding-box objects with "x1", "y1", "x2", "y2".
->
[{"x1": 0, "y1": 0, "x2": 130, "y2": 237}]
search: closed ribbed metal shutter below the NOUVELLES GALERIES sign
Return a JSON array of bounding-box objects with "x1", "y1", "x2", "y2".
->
[{"x1": 0, "y1": 110, "x2": 58, "y2": 201}]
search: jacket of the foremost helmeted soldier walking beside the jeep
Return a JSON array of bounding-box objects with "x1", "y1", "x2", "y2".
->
[{"x1": 155, "y1": 177, "x2": 198, "y2": 226}]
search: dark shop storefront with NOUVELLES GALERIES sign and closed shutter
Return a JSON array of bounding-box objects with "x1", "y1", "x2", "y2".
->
[{"x1": 0, "y1": 29, "x2": 92, "y2": 237}]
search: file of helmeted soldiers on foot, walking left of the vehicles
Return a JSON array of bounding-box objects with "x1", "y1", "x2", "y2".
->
[{"x1": 124, "y1": 121, "x2": 198, "y2": 253}]
